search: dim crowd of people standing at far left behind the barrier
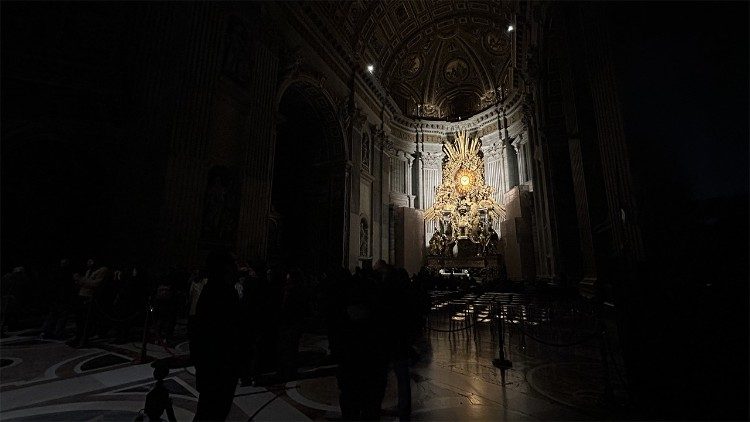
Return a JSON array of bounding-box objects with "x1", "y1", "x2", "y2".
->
[{"x1": 0, "y1": 258, "x2": 153, "y2": 347}]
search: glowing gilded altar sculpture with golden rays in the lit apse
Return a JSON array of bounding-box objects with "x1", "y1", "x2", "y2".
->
[{"x1": 425, "y1": 131, "x2": 505, "y2": 255}]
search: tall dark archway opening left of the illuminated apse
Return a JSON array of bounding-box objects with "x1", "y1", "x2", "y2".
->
[{"x1": 269, "y1": 75, "x2": 348, "y2": 272}]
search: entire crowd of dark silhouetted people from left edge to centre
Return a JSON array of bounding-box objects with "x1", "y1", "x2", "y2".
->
[{"x1": 2, "y1": 252, "x2": 435, "y2": 420}]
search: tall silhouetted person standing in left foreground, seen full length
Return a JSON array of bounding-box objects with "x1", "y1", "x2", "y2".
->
[{"x1": 190, "y1": 252, "x2": 241, "y2": 421}]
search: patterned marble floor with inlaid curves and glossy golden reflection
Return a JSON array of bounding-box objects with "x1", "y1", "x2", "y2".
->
[{"x1": 0, "y1": 292, "x2": 632, "y2": 421}]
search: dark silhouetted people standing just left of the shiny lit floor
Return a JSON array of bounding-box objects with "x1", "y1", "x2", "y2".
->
[{"x1": 326, "y1": 260, "x2": 429, "y2": 420}]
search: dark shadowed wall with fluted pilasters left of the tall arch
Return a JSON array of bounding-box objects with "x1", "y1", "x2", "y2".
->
[{"x1": 0, "y1": 2, "x2": 278, "y2": 269}]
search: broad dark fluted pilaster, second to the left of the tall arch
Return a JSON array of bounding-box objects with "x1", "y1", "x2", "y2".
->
[{"x1": 155, "y1": 3, "x2": 223, "y2": 265}]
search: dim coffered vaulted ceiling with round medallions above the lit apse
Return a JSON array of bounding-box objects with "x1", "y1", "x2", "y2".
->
[{"x1": 286, "y1": 0, "x2": 515, "y2": 119}]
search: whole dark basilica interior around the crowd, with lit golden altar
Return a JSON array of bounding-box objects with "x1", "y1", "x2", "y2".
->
[{"x1": 0, "y1": 0, "x2": 748, "y2": 421}]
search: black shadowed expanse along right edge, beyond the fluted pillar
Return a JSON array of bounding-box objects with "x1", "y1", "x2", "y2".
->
[{"x1": 610, "y1": 2, "x2": 748, "y2": 419}]
